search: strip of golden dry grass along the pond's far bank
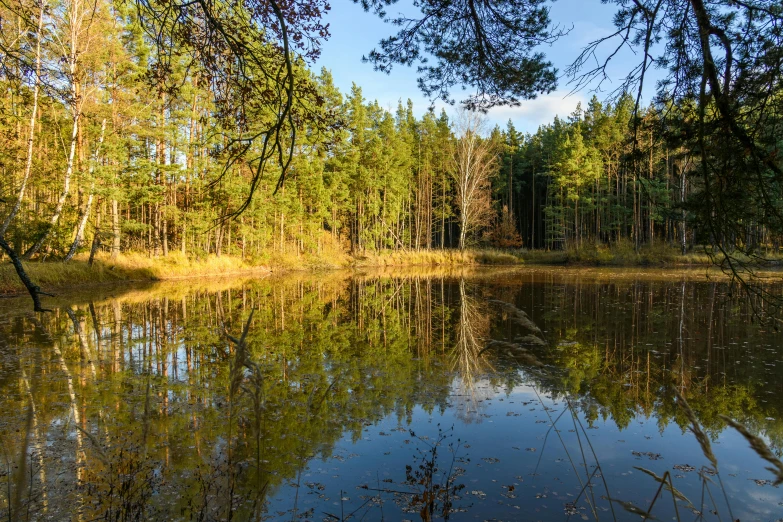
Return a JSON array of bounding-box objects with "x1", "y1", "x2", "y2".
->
[{"x1": 0, "y1": 240, "x2": 776, "y2": 295}]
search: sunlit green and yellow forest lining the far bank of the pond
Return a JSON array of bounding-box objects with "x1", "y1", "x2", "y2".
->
[{"x1": 0, "y1": 0, "x2": 781, "y2": 276}]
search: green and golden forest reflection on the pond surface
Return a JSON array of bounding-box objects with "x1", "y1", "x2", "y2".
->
[{"x1": 0, "y1": 271, "x2": 783, "y2": 520}]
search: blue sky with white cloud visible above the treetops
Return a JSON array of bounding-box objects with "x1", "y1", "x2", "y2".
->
[{"x1": 315, "y1": 0, "x2": 654, "y2": 132}]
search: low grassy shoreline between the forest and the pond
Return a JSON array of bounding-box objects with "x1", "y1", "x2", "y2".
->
[{"x1": 0, "y1": 250, "x2": 776, "y2": 299}]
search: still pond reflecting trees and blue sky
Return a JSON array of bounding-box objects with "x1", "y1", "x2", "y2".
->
[{"x1": 0, "y1": 268, "x2": 783, "y2": 521}]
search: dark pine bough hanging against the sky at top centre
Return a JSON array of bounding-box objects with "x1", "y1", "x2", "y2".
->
[{"x1": 354, "y1": 0, "x2": 564, "y2": 110}]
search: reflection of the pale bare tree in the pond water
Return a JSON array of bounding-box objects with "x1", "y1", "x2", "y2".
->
[{"x1": 451, "y1": 278, "x2": 494, "y2": 422}]
